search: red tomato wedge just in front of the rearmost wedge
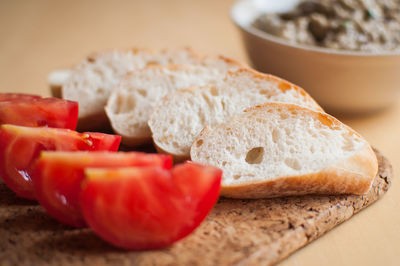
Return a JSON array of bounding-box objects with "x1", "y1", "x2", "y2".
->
[{"x1": 0, "y1": 125, "x2": 121, "y2": 199}]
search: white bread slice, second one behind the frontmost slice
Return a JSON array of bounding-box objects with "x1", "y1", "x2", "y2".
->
[{"x1": 105, "y1": 56, "x2": 244, "y2": 146}]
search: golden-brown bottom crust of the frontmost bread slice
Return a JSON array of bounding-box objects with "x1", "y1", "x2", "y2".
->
[{"x1": 221, "y1": 143, "x2": 378, "y2": 199}]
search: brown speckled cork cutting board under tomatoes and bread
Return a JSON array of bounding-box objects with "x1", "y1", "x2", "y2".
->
[{"x1": 0, "y1": 151, "x2": 392, "y2": 265}]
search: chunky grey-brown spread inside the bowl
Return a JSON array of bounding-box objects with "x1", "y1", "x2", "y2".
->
[{"x1": 253, "y1": 0, "x2": 400, "y2": 52}]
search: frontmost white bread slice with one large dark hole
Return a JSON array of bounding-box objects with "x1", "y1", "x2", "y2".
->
[{"x1": 190, "y1": 103, "x2": 378, "y2": 198}]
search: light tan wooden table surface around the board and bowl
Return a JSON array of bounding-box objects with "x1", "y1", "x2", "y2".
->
[{"x1": 0, "y1": 0, "x2": 400, "y2": 266}]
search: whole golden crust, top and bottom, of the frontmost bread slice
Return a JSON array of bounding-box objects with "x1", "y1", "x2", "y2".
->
[{"x1": 191, "y1": 103, "x2": 378, "y2": 199}]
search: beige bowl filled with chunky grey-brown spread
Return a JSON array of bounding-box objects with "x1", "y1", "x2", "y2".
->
[{"x1": 231, "y1": 0, "x2": 400, "y2": 114}]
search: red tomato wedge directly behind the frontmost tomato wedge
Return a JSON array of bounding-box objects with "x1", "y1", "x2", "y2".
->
[{"x1": 33, "y1": 152, "x2": 172, "y2": 227}]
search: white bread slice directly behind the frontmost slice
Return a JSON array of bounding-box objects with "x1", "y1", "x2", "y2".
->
[{"x1": 149, "y1": 69, "x2": 322, "y2": 161}]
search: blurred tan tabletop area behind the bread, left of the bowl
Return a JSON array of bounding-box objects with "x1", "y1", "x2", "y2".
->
[{"x1": 0, "y1": 0, "x2": 246, "y2": 94}]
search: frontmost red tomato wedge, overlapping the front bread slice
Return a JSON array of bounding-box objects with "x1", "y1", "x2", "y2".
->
[{"x1": 81, "y1": 163, "x2": 222, "y2": 250}]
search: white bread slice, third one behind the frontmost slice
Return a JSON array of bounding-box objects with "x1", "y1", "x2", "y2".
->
[{"x1": 62, "y1": 48, "x2": 209, "y2": 130}]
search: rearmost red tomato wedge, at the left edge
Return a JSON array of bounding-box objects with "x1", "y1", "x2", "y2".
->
[{"x1": 0, "y1": 94, "x2": 78, "y2": 129}]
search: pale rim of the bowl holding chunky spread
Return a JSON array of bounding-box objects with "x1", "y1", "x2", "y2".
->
[{"x1": 229, "y1": 0, "x2": 400, "y2": 57}]
